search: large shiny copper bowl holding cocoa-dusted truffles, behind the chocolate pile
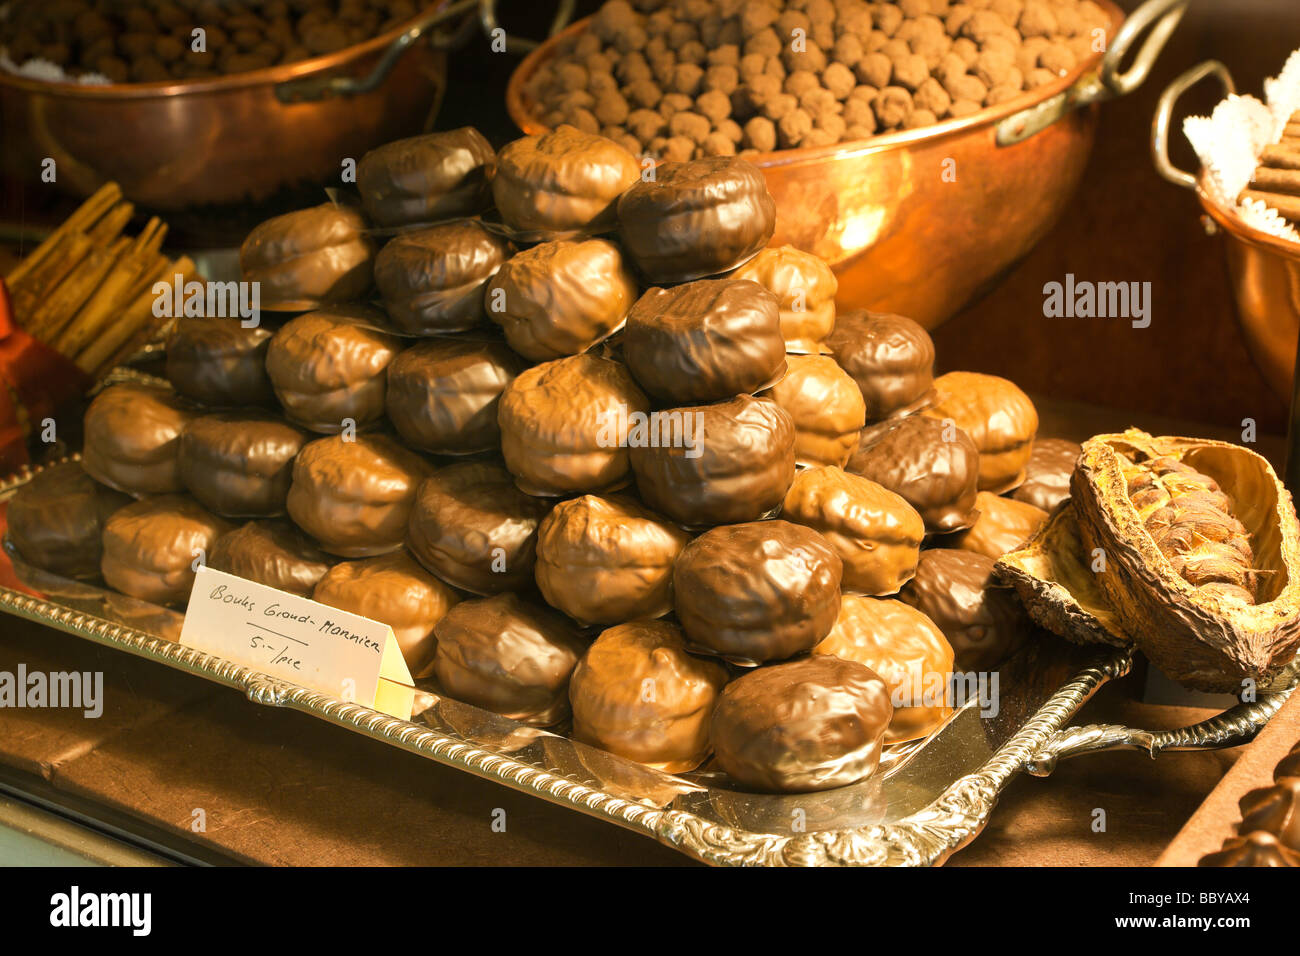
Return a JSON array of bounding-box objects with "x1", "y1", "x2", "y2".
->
[{"x1": 506, "y1": 0, "x2": 1187, "y2": 329}]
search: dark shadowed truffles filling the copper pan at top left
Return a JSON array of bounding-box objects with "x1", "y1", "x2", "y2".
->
[{"x1": 0, "y1": 0, "x2": 424, "y2": 83}]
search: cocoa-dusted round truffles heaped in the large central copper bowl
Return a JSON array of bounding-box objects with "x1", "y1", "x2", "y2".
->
[{"x1": 527, "y1": 0, "x2": 1109, "y2": 161}]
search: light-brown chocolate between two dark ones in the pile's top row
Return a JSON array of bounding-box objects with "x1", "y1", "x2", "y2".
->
[{"x1": 491, "y1": 126, "x2": 641, "y2": 233}]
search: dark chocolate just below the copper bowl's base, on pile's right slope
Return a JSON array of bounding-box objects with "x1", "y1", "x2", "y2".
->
[{"x1": 826, "y1": 310, "x2": 935, "y2": 421}]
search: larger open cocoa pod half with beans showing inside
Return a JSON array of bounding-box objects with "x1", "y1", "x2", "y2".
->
[{"x1": 1070, "y1": 429, "x2": 1300, "y2": 692}]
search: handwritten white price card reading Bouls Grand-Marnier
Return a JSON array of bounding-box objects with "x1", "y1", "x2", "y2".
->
[{"x1": 181, "y1": 567, "x2": 415, "y2": 721}]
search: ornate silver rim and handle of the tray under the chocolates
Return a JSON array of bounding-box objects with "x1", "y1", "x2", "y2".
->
[{"x1": 0, "y1": 455, "x2": 1288, "y2": 866}]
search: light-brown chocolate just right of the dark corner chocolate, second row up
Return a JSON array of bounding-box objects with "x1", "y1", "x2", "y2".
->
[{"x1": 781, "y1": 466, "x2": 926, "y2": 594}]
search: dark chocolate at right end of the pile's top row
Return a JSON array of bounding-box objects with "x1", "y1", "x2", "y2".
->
[{"x1": 619, "y1": 156, "x2": 776, "y2": 282}]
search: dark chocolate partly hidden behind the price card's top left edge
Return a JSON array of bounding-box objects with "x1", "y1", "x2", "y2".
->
[{"x1": 208, "y1": 519, "x2": 333, "y2": 597}]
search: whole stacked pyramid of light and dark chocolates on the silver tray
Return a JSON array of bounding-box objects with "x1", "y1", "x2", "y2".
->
[{"x1": 9, "y1": 127, "x2": 1076, "y2": 791}]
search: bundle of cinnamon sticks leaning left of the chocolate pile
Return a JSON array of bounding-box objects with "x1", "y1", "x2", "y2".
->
[{"x1": 5, "y1": 182, "x2": 195, "y2": 378}]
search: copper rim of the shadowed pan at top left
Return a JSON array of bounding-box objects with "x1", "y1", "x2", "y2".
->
[{"x1": 0, "y1": 0, "x2": 449, "y2": 101}]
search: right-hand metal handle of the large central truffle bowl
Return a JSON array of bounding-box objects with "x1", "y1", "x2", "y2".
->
[{"x1": 997, "y1": 0, "x2": 1190, "y2": 146}]
